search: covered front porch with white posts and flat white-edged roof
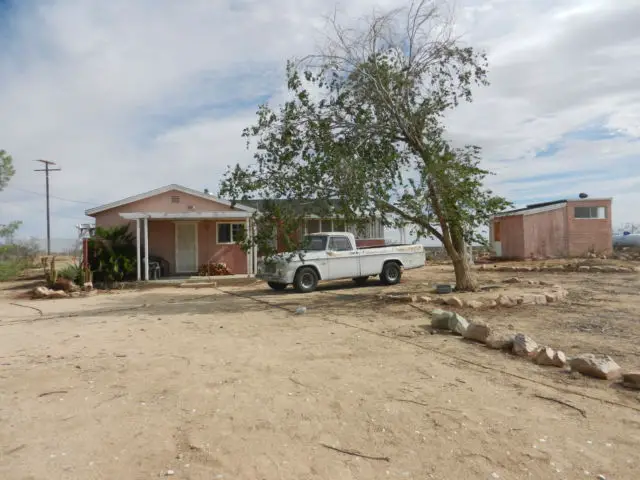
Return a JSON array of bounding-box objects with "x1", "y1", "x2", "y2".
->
[{"x1": 119, "y1": 211, "x2": 257, "y2": 283}]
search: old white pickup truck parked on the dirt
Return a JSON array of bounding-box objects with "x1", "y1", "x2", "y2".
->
[{"x1": 256, "y1": 232, "x2": 425, "y2": 293}]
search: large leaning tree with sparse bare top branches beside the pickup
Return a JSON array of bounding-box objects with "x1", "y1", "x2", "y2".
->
[{"x1": 220, "y1": 0, "x2": 508, "y2": 290}]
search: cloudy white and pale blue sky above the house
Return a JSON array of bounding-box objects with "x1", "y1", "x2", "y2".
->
[{"x1": 0, "y1": 0, "x2": 640, "y2": 244}]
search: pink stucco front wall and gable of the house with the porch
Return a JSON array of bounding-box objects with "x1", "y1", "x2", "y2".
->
[{"x1": 89, "y1": 190, "x2": 247, "y2": 274}]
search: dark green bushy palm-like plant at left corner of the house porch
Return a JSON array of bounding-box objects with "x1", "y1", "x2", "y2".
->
[{"x1": 88, "y1": 225, "x2": 137, "y2": 285}]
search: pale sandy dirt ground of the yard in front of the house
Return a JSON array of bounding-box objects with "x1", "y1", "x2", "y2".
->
[{"x1": 0, "y1": 266, "x2": 640, "y2": 480}]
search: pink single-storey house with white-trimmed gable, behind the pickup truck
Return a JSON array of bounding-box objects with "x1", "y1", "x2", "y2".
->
[{"x1": 85, "y1": 184, "x2": 385, "y2": 280}]
